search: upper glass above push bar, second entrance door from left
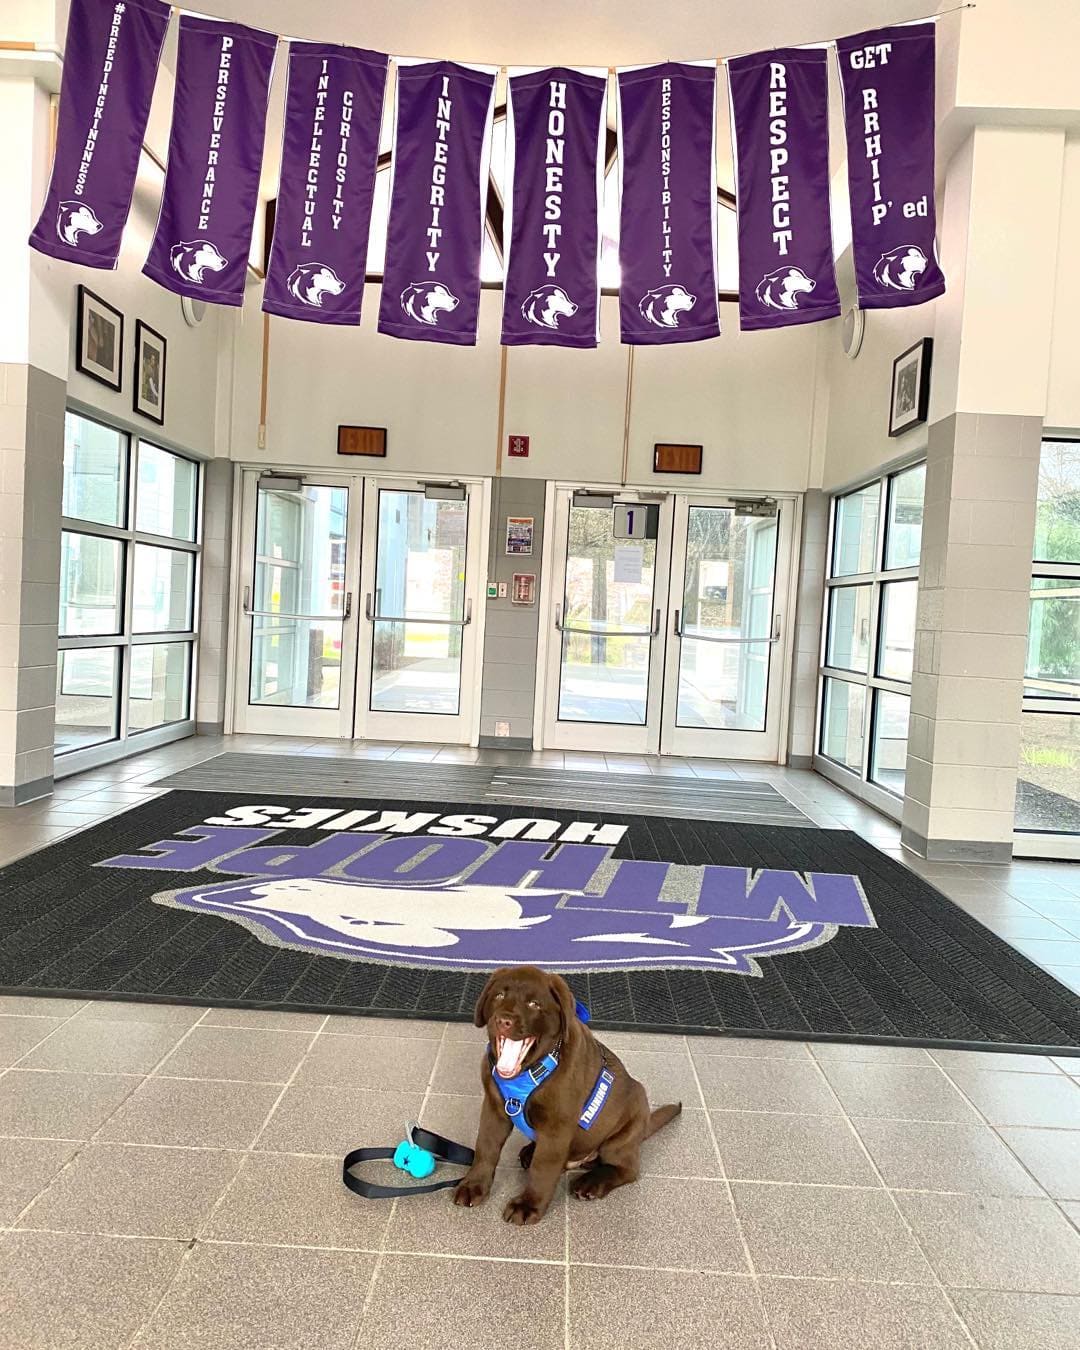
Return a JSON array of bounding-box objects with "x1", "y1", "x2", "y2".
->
[{"x1": 375, "y1": 490, "x2": 468, "y2": 621}]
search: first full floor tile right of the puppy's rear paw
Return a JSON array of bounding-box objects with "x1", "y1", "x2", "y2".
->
[{"x1": 713, "y1": 1111, "x2": 880, "y2": 1185}]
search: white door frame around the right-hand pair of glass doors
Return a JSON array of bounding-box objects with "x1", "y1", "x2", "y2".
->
[{"x1": 532, "y1": 479, "x2": 803, "y2": 764}]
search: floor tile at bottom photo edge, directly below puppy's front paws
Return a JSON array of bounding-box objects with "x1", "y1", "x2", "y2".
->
[{"x1": 361, "y1": 1256, "x2": 566, "y2": 1350}]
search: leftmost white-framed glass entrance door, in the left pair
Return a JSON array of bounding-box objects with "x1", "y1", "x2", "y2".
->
[{"x1": 234, "y1": 471, "x2": 360, "y2": 736}]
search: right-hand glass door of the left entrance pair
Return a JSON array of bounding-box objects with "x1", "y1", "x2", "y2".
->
[{"x1": 356, "y1": 481, "x2": 485, "y2": 744}]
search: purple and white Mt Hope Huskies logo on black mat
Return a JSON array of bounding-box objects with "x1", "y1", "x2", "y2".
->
[{"x1": 97, "y1": 806, "x2": 875, "y2": 976}]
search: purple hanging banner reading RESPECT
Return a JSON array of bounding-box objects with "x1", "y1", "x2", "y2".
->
[{"x1": 728, "y1": 47, "x2": 840, "y2": 329}]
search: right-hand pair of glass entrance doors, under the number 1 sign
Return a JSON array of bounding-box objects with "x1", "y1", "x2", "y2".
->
[{"x1": 544, "y1": 489, "x2": 794, "y2": 761}]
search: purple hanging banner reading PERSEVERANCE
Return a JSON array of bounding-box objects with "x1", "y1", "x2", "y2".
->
[{"x1": 143, "y1": 14, "x2": 277, "y2": 305}]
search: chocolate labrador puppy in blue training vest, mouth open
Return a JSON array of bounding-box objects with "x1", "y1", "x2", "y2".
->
[{"x1": 454, "y1": 965, "x2": 682, "y2": 1224}]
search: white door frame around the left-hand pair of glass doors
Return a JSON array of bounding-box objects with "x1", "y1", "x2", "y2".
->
[{"x1": 223, "y1": 460, "x2": 491, "y2": 747}]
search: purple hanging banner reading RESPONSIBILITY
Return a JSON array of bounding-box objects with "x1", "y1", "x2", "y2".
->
[{"x1": 618, "y1": 62, "x2": 720, "y2": 344}]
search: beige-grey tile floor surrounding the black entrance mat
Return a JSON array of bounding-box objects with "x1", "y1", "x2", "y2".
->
[{"x1": 0, "y1": 737, "x2": 1080, "y2": 1350}]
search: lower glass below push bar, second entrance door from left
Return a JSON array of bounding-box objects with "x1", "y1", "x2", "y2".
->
[{"x1": 371, "y1": 621, "x2": 463, "y2": 717}]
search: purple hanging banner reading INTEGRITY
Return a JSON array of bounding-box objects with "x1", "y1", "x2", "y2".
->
[{"x1": 379, "y1": 61, "x2": 495, "y2": 347}]
